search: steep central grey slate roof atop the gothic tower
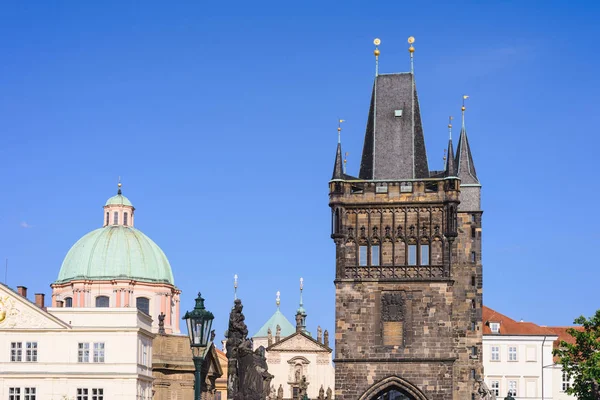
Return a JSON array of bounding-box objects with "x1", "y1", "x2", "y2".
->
[{"x1": 359, "y1": 73, "x2": 429, "y2": 180}]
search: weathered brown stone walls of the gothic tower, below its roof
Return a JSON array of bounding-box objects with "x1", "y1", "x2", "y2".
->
[{"x1": 330, "y1": 180, "x2": 482, "y2": 400}]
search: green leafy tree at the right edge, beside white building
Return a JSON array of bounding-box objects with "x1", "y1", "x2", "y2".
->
[{"x1": 554, "y1": 310, "x2": 600, "y2": 400}]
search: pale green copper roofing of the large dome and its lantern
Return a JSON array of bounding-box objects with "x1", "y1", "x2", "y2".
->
[{"x1": 55, "y1": 225, "x2": 174, "y2": 284}]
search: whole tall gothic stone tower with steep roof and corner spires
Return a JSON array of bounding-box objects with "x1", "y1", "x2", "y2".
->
[{"x1": 329, "y1": 68, "x2": 483, "y2": 400}]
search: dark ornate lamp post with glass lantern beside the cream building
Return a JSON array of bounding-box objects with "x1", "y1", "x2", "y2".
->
[{"x1": 183, "y1": 293, "x2": 215, "y2": 400}]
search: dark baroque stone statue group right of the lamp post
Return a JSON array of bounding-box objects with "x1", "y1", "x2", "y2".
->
[{"x1": 225, "y1": 299, "x2": 273, "y2": 400}]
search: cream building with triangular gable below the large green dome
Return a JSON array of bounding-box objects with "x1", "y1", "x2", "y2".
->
[{"x1": 0, "y1": 284, "x2": 154, "y2": 400}]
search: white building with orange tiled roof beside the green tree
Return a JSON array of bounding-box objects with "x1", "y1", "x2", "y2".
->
[{"x1": 482, "y1": 306, "x2": 575, "y2": 400}]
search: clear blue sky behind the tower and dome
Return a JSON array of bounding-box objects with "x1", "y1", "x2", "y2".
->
[{"x1": 0, "y1": 1, "x2": 600, "y2": 336}]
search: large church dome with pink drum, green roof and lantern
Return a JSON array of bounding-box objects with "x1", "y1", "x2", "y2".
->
[{"x1": 51, "y1": 183, "x2": 180, "y2": 333}]
